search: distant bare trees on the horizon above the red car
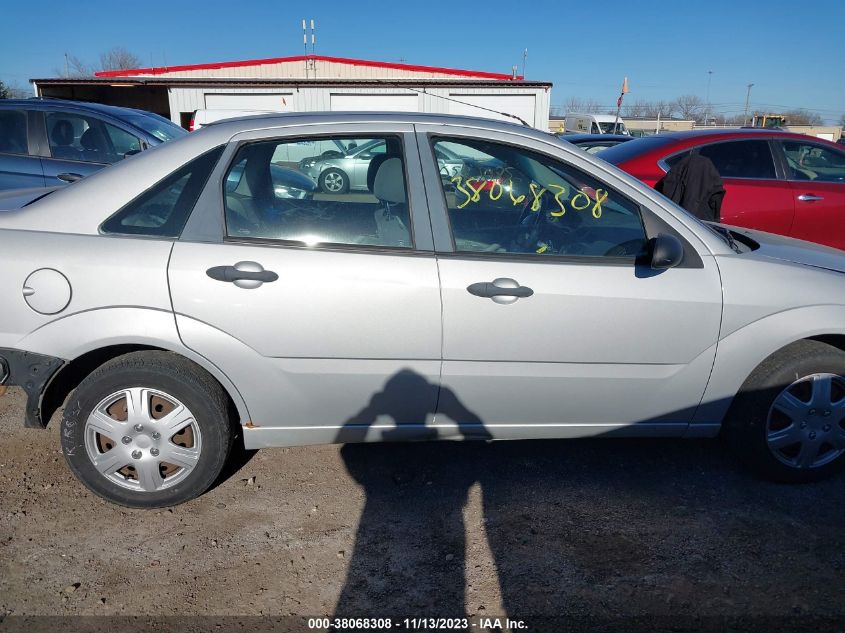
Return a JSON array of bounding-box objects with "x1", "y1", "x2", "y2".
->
[{"x1": 550, "y1": 95, "x2": 828, "y2": 127}]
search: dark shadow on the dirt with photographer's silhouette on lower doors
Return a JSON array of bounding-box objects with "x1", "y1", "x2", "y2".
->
[{"x1": 335, "y1": 372, "x2": 845, "y2": 619}]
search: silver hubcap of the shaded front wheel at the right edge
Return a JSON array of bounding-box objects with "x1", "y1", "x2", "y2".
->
[{"x1": 766, "y1": 374, "x2": 845, "y2": 469}]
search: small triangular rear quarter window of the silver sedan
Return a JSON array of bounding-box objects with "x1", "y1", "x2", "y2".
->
[{"x1": 100, "y1": 145, "x2": 223, "y2": 238}]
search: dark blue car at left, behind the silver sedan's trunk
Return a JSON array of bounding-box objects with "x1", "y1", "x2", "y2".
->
[{"x1": 0, "y1": 99, "x2": 187, "y2": 190}]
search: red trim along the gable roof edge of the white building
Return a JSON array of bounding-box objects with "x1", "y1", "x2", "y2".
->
[{"x1": 94, "y1": 55, "x2": 523, "y2": 81}]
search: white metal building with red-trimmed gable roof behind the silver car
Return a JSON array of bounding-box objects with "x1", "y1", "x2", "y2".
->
[{"x1": 33, "y1": 55, "x2": 552, "y2": 129}]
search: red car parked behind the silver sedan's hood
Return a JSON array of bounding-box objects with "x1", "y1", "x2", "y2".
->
[{"x1": 601, "y1": 129, "x2": 845, "y2": 250}]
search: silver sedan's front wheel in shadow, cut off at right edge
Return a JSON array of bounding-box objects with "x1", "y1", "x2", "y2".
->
[{"x1": 723, "y1": 340, "x2": 845, "y2": 483}]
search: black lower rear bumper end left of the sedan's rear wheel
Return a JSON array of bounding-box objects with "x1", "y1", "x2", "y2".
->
[{"x1": 0, "y1": 348, "x2": 65, "y2": 429}]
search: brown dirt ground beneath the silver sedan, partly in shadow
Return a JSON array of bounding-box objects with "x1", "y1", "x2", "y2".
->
[{"x1": 0, "y1": 390, "x2": 845, "y2": 624}]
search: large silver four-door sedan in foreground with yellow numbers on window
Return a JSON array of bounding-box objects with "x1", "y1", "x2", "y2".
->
[{"x1": 0, "y1": 113, "x2": 845, "y2": 507}]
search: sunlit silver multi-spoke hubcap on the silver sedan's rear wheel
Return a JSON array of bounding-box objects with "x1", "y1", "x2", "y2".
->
[{"x1": 85, "y1": 387, "x2": 202, "y2": 492}]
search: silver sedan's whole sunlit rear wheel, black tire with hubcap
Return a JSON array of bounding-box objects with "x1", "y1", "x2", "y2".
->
[{"x1": 61, "y1": 351, "x2": 233, "y2": 508}]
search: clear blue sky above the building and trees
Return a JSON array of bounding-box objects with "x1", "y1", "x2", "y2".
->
[{"x1": 0, "y1": 0, "x2": 845, "y2": 122}]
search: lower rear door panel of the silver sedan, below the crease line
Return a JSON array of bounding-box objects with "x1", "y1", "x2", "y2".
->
[{"x1": 169, "y1": 314, "x2": 440, "y2": 449}]
